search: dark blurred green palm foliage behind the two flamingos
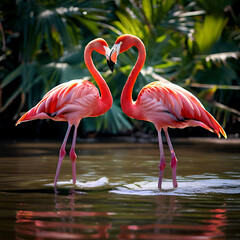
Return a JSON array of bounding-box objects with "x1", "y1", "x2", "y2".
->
[{"x1": 0, "y1": 0, "x2": 240, "y2": 140}]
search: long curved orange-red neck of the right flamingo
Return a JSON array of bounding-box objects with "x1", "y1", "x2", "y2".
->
[{"x1": 121, "y1": 38, "x2": 146, "y2": 119}]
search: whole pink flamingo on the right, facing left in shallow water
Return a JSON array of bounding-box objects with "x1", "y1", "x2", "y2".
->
[{"x1": 107, "y1": 34, "x2": 227, "y2": 189}]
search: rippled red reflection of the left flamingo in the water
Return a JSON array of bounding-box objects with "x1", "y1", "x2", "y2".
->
[{"x1": 16, "y1": 191, "x2": 113, "y2": 239}]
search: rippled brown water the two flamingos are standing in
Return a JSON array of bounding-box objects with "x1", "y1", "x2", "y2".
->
[{"x1": 0, "y1": 140, "x2": 240, "y2": 240}]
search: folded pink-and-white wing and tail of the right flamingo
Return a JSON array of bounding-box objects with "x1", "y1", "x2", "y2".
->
[{"x1": 138, "y1": 81, "x2": 226, "y2": 138}]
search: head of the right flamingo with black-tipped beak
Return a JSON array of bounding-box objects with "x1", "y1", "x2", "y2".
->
[{"x1": 107, "y1": 34, "x2": 141, "y2": 72}]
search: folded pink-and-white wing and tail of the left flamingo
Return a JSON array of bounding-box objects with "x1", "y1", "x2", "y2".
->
[{"x1": 16, "y1": 80, "x2": 99, "y2": 125}]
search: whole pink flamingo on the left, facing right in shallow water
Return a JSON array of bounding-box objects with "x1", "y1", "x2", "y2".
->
[{"x1": 16, "y1": 38, "x2": 113, "y2": 186}]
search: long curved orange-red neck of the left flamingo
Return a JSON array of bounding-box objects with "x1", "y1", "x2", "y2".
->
[{"x1": 84, "y1": 44, "x2": 113, "y2": 114}]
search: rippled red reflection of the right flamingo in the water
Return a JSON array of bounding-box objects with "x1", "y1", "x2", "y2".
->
[{"x1": 118, "y1": 197, "x2": 227, "y2": 240}]
